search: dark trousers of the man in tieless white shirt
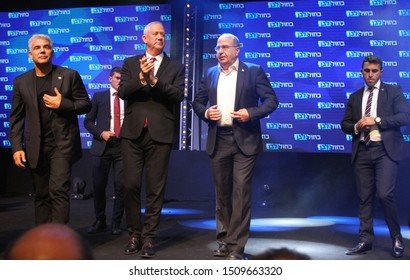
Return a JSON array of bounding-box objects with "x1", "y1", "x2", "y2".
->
[{"x1": 211, "y1": 131, "x2": 257, "y2": 253}]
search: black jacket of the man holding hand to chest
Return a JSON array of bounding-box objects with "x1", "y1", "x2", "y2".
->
[{"x1": 10, "y1": 66, "x2": 91, "y2": 168}]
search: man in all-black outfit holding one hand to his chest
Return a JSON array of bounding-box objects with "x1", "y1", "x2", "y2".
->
[{"x1": 10, "y1": 34, "x2": 91, "y2": 224}]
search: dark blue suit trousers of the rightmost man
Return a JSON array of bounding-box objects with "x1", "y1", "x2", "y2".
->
[{"x1": 354, "y1": 142, "x2": 401, "y2": 243}]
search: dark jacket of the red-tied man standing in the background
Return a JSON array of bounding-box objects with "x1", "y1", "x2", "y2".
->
[{"x1": 84, "y1": 90, "x2": 111, "y2": 156}]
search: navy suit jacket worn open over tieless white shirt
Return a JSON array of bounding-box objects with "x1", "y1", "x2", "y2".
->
[{"x1": 193, "y1": 62, "x2": 279, "y2": 155}]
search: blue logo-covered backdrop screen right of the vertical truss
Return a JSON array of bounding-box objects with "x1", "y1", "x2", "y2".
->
[{"x1": 203, "y1": 0, "x2": 410, "y2": 153}]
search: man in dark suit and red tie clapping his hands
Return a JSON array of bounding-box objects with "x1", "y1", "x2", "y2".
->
[{"x1": 119, "y1": 22, "x2": 184, "y2": 258}]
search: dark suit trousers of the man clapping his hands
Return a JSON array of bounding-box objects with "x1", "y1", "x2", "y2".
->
[{"x1": 121, "y1": 128, "x2": 172, "y2": 242}]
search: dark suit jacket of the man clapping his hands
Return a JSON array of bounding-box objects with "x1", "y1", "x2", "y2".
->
[{"x1": 118, "y1": 53, "x2": 184, "y2": 144}]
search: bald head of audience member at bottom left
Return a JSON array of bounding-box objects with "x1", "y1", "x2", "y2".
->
[{"x1": 5, "y1": 223, "x2": 94, "y2": 260}]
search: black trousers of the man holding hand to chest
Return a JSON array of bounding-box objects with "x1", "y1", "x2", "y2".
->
[{"x1": 31, "y1": 145, "x2": 72, "y2": 225}]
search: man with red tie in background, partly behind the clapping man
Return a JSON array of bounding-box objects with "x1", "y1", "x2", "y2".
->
[{"x1": 84, "y1": 67, "x2": 124, "y2": 235}]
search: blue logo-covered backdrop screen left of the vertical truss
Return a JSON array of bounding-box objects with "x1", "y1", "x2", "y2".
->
[{"x1": 0, "y1": 4, "x2": 171, "y2": 148}]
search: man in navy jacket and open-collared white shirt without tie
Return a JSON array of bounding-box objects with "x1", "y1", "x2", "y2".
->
[{"x1": 193, "y1": 34, "x2": 279, "y2": 259}]
